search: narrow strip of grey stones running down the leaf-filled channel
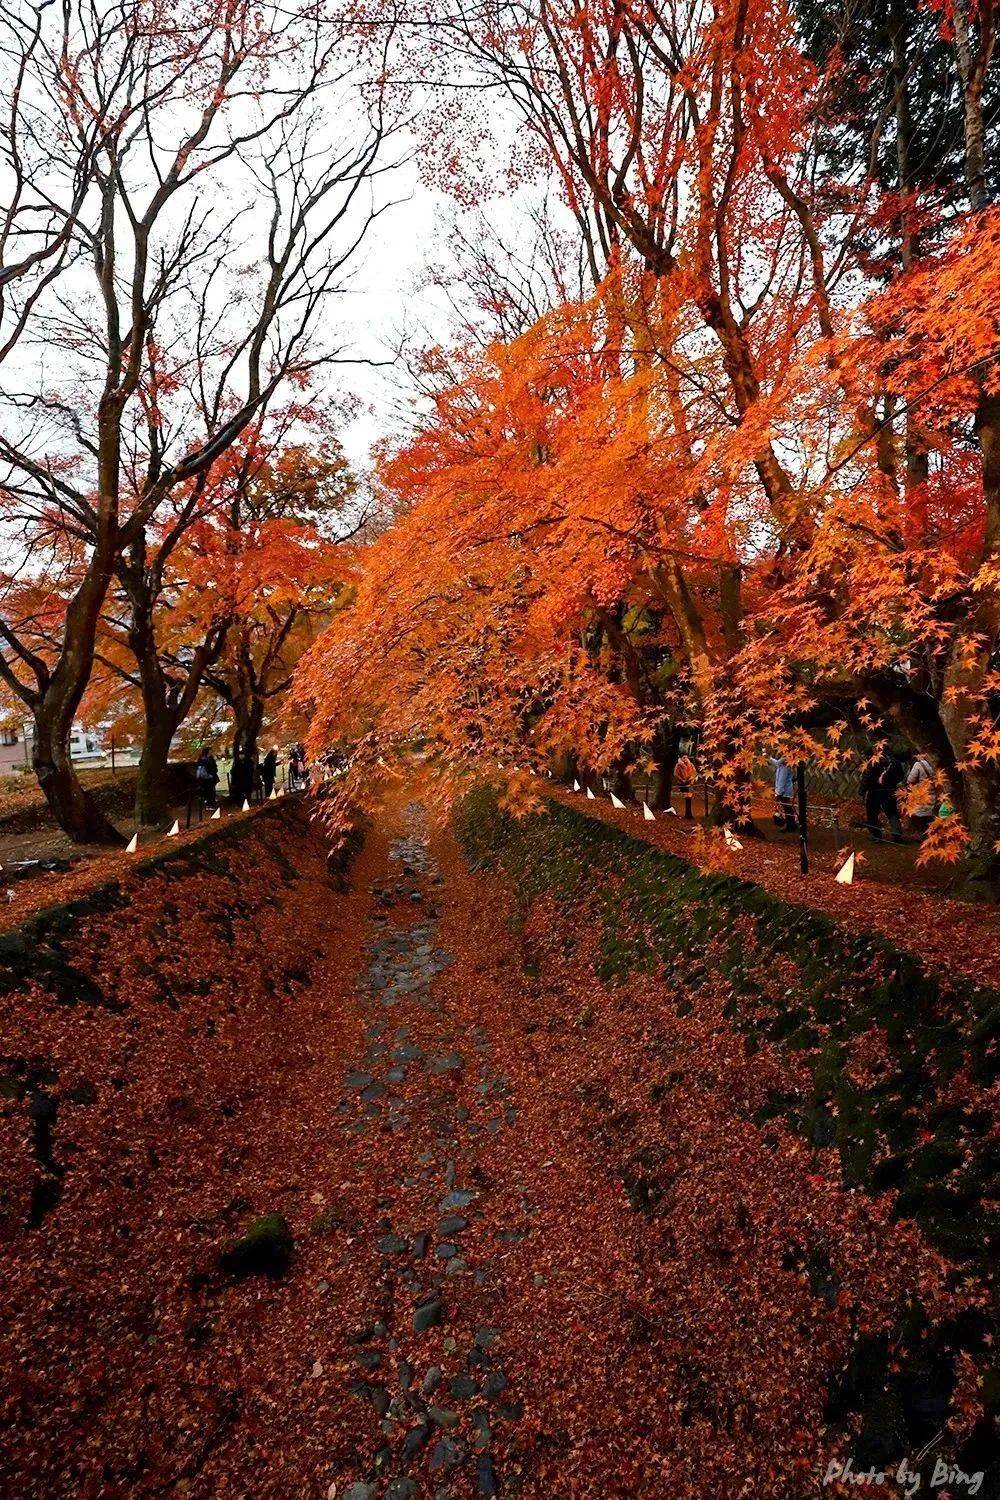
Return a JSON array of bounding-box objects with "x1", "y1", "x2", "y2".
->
[{"x1": 340, "y1": 804, "x2": 520, "y2": 1500}]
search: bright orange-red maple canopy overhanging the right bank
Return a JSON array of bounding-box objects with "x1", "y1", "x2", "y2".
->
[{"x1": 301, "y1": 3, "x2": 1000, "y2": 890}]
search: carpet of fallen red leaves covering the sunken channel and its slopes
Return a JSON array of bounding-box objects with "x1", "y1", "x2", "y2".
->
[{"x1": 0, "y1": 795, "x2": 988, "y2": 1500}]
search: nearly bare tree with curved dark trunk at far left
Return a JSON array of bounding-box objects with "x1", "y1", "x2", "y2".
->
[{"x1": 0, "y1": 0, "x2": 388, "y2": 842}]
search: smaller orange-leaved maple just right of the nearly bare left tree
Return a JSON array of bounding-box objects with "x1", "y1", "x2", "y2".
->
[{"x1": 84, "y1": 435, "x2": 355, "y2": 824}]
